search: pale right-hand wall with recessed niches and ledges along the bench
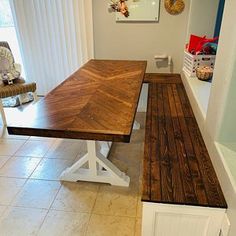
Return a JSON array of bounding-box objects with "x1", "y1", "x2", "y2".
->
[{"x1": 182, "y1": 0, "x2": 236, "y2": 236}]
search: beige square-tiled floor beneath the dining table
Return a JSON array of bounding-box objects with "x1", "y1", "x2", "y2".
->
[{"x1": 0, "y1": 113, "x2": 145, "y2": 236}]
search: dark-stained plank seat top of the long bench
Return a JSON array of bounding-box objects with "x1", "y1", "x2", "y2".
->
[{"x1": 142, "y1": 74, "x2": 227, "y2": 208}]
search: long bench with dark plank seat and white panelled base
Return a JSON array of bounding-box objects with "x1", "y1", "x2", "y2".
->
[{"x1": 142, "y1": 74, "x2": 227, "y2": 236}]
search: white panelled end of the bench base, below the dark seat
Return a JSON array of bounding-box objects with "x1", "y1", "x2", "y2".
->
[{"x1": 142, "y1": 202, "x2": 226, "y2": 236}]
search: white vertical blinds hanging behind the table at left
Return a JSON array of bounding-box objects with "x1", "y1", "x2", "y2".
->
[{"x1": 10, "y1": 0, "x2": 93, "y2": 95}]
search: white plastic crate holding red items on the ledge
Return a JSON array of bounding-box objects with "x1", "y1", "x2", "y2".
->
[{"x1": 183, "y1": 51, "x2": 216, "y2": 76}]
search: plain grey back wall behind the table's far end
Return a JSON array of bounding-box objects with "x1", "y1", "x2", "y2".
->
[{"x1": 93, "y1": 0, "x2": 189, "y2": 72}]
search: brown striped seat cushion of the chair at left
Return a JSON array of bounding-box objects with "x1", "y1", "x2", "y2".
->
[{"x1": 0, "y1": 79, "x2": 36, "y2": 98}]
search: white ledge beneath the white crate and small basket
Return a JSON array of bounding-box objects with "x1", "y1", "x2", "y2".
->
[{"x1": 183, "y1": 72, "x2": 211, "y2": 119}]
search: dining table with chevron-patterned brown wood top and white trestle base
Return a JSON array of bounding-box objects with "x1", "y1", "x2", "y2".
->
[{"x1": 7, "y1": 59, "x2": 147, "y2": 186}]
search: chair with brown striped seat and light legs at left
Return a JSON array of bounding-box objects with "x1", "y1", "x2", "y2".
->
[{"x1": 0, "y1": 42, "x2": 37, "y2": 125}]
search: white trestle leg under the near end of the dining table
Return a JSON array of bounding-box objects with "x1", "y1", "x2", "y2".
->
[{"x1": 60, "y1": 141, "x2": 130, "y2": 187}]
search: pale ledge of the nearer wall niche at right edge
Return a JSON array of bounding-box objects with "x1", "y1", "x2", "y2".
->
[{"x1": 215, "y1": 142, "x2": 236, "y2": 192}]
